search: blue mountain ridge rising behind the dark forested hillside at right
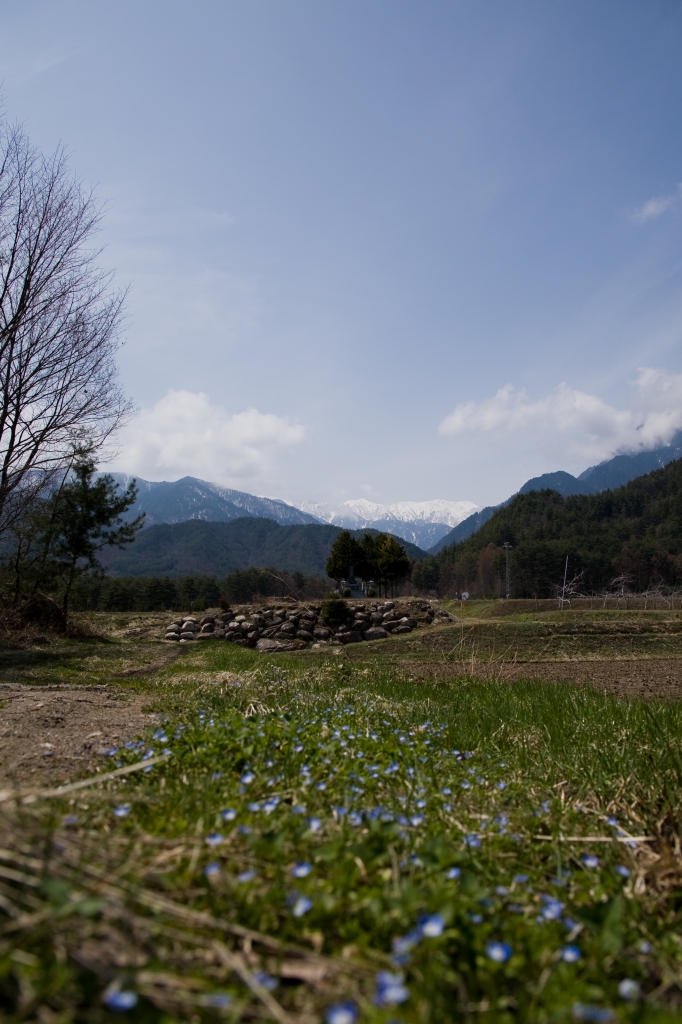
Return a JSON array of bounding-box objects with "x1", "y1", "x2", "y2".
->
[{"x1": 428, "y1": 430, "x2": 682, "y2": 555}]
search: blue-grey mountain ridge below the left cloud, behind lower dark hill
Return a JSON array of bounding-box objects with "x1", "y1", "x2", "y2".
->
[{"x1": 111, "y1": 473, "x2": 321, "y2": 527}]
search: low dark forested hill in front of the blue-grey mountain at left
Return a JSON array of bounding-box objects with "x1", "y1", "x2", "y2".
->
[{"x1": 100, "y1": 516, "x2": 426, "y2": 577}]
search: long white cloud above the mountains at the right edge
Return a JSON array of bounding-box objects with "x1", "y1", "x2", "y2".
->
[{"x1": 438, "y1": 368, "x2": 682, "y2": 460}]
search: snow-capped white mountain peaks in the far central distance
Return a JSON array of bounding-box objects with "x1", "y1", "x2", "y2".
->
[{"x1": 300, "y1": 498, "x2": 478, "y2": 550}]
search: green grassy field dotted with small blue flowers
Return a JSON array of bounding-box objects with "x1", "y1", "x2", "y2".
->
[{"x1": 0, "y1": 605, "x2": 682, "y2": 1024}]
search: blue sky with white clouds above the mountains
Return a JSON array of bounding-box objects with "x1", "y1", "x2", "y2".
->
[{"x1": 0, "y1": 0, "x2": 682, "y2": 505}]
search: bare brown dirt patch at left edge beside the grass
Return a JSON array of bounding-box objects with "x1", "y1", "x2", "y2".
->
[{"x1": 0, "y1": 683, "x2": 157, "y2": 787}]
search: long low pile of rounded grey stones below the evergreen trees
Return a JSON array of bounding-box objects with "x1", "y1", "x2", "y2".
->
[{"x1": 166, "y1": 601, "x2": 453, "y2": 651}]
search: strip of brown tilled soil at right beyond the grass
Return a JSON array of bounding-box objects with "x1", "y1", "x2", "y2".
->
[{"x1": 410, "y1": 658, "x2": 682, "y2": 700}]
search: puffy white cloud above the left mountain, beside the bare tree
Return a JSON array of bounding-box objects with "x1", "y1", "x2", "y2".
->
[{"x1": 110, "y1": 391, "x2": 305, "y2": 485}]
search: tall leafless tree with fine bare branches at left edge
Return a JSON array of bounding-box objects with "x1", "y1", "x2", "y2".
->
[{"x1": 0, "y1": 119, "x2": 129, "y2": 532}]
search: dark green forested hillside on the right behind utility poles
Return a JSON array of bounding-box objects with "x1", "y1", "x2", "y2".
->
[{"x1": 413, "y1": 460, "x2": 682, "y2": 597}]
